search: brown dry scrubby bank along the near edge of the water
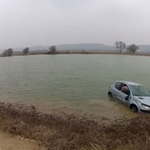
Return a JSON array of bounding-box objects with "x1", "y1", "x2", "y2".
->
[{"x1": 0, "y1": 103, "x2": 150, "y2": 150}]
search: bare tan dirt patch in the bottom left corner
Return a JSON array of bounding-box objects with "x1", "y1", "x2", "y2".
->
[{"x1": 0, "y1": 131, "x2": 46, "y2": 150}]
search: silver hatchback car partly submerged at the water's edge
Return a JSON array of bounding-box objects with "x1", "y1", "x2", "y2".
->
[{"x1": 108, "y1": 81, "x2": 150, "y2": 113}]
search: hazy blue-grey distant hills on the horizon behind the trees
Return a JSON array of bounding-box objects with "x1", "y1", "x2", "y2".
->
[{"x1": 2, "y1": 43, "x2": 150, "y2": 53}]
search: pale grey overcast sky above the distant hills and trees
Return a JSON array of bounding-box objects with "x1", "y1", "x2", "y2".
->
[{"x1": 0, "y1": 0, "x2": 150, "y2": 48}]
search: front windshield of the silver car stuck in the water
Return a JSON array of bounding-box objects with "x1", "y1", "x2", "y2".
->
[{"x1": 130, "y1": 85, "x2": 150, "y2": 96}]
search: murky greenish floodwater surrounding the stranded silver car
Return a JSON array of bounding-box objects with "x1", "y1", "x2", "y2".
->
[{"x1": 0, "y1": 54, "x2": 150, "y2": 117}]
